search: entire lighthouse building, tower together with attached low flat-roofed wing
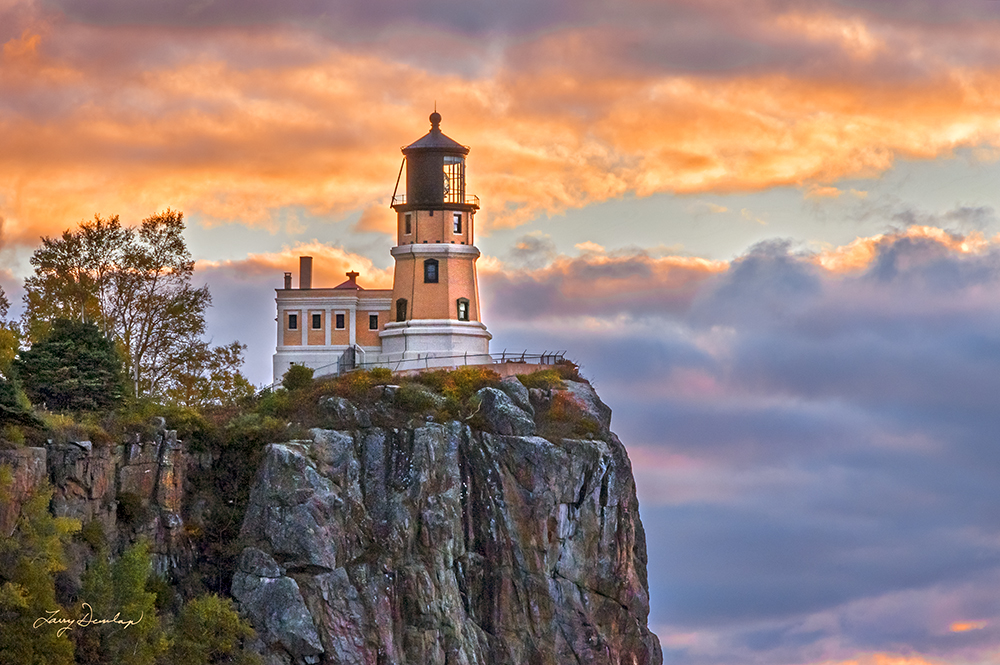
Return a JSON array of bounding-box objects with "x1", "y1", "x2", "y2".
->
[{"x1": 274, "y1": 111, "x2": 492, "y2": 381}]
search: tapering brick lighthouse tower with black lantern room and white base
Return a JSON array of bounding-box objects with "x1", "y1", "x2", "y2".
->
[{"x1": 379, "y1": 111, "x2": 492, "y2": 365}]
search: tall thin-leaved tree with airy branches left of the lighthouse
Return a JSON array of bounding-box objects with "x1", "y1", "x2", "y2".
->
[{"x1": 24, "y1": 209, "x2": 242, "y2": 396}]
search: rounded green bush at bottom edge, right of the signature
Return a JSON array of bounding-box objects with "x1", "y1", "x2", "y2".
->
[{"x1": 167, "y1": 594, "x2": 261, "y2": 665}]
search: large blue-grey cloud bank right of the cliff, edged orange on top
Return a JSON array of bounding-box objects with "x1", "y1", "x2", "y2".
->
[{"x1": 481, "y1": 224, "x2": 1000, "y2": 665}]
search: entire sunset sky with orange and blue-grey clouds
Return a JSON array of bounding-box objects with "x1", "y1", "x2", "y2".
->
[{"x1": 9, "y1": 0, "x2": 1000, "y2": 665}]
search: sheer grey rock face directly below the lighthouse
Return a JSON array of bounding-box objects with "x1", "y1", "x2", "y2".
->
[{"x1": 232, "y1": 383, "x2": 662, "y2": 665}]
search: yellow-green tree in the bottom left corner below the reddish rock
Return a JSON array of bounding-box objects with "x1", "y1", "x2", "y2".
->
[{"x1": 0, "y1": 474, "x2": 80, "y2": 665}]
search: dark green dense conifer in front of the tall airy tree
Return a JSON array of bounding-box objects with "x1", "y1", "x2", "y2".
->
[{"x1": 15, "y1": 319, "x2": 124, "y2": 411}]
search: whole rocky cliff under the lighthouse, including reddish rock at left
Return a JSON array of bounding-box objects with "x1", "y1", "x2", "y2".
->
[{"x1": 0, "y1": 370, "x2": 662, "y2": 665}]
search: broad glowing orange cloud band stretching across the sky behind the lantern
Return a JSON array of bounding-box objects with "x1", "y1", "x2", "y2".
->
[{"x1": 0, "y1": 5, "x2": 1000, "y2": 252}]
